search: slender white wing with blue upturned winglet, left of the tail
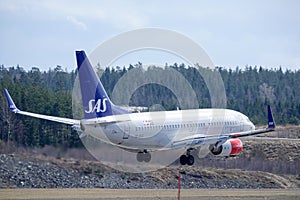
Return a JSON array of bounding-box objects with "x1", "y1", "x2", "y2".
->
[{"x1": 4, "y1": 89, "x2": 80, "y2": 125}]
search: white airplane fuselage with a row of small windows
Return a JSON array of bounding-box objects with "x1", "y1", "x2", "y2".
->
[{"x1": 81, "y1": 109, "x2": 255, "y2": 150}]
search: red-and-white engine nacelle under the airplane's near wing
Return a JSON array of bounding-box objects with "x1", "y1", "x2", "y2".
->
[{"x1": 210, "y1": 138, "x2": 243, "y2": 156}]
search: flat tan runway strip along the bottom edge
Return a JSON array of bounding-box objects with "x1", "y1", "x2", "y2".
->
[{"x1": 0, "y1": 188, "x2": 300, "y2": 200}]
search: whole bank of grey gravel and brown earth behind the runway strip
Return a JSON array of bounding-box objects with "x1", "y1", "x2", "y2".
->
[{"x1": 0, "y1": 154, "x2": 300, "y2": 189}]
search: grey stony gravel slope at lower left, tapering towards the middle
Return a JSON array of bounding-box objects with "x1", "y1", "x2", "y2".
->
[{"x1": 0, "y1": 154, "x2": 158, "y2": 188}]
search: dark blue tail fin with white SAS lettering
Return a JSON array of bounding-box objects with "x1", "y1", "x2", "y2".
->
[{"x1": 76, "y1": 51, "x2": 129, "y2": 119}]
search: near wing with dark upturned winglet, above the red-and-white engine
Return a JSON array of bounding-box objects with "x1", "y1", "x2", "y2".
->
[{"x1": 172, "y1": 105, "x2": 275, "y2": 149}]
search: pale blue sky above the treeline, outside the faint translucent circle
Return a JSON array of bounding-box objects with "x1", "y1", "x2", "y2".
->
[{"x1": 0, "y1": 0, "x2": 300, "y2": 71}]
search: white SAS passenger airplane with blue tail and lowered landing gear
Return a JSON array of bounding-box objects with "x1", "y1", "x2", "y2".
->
[{"x1": 4, "y1": 50, "x2": 275, "y2": 165}]
